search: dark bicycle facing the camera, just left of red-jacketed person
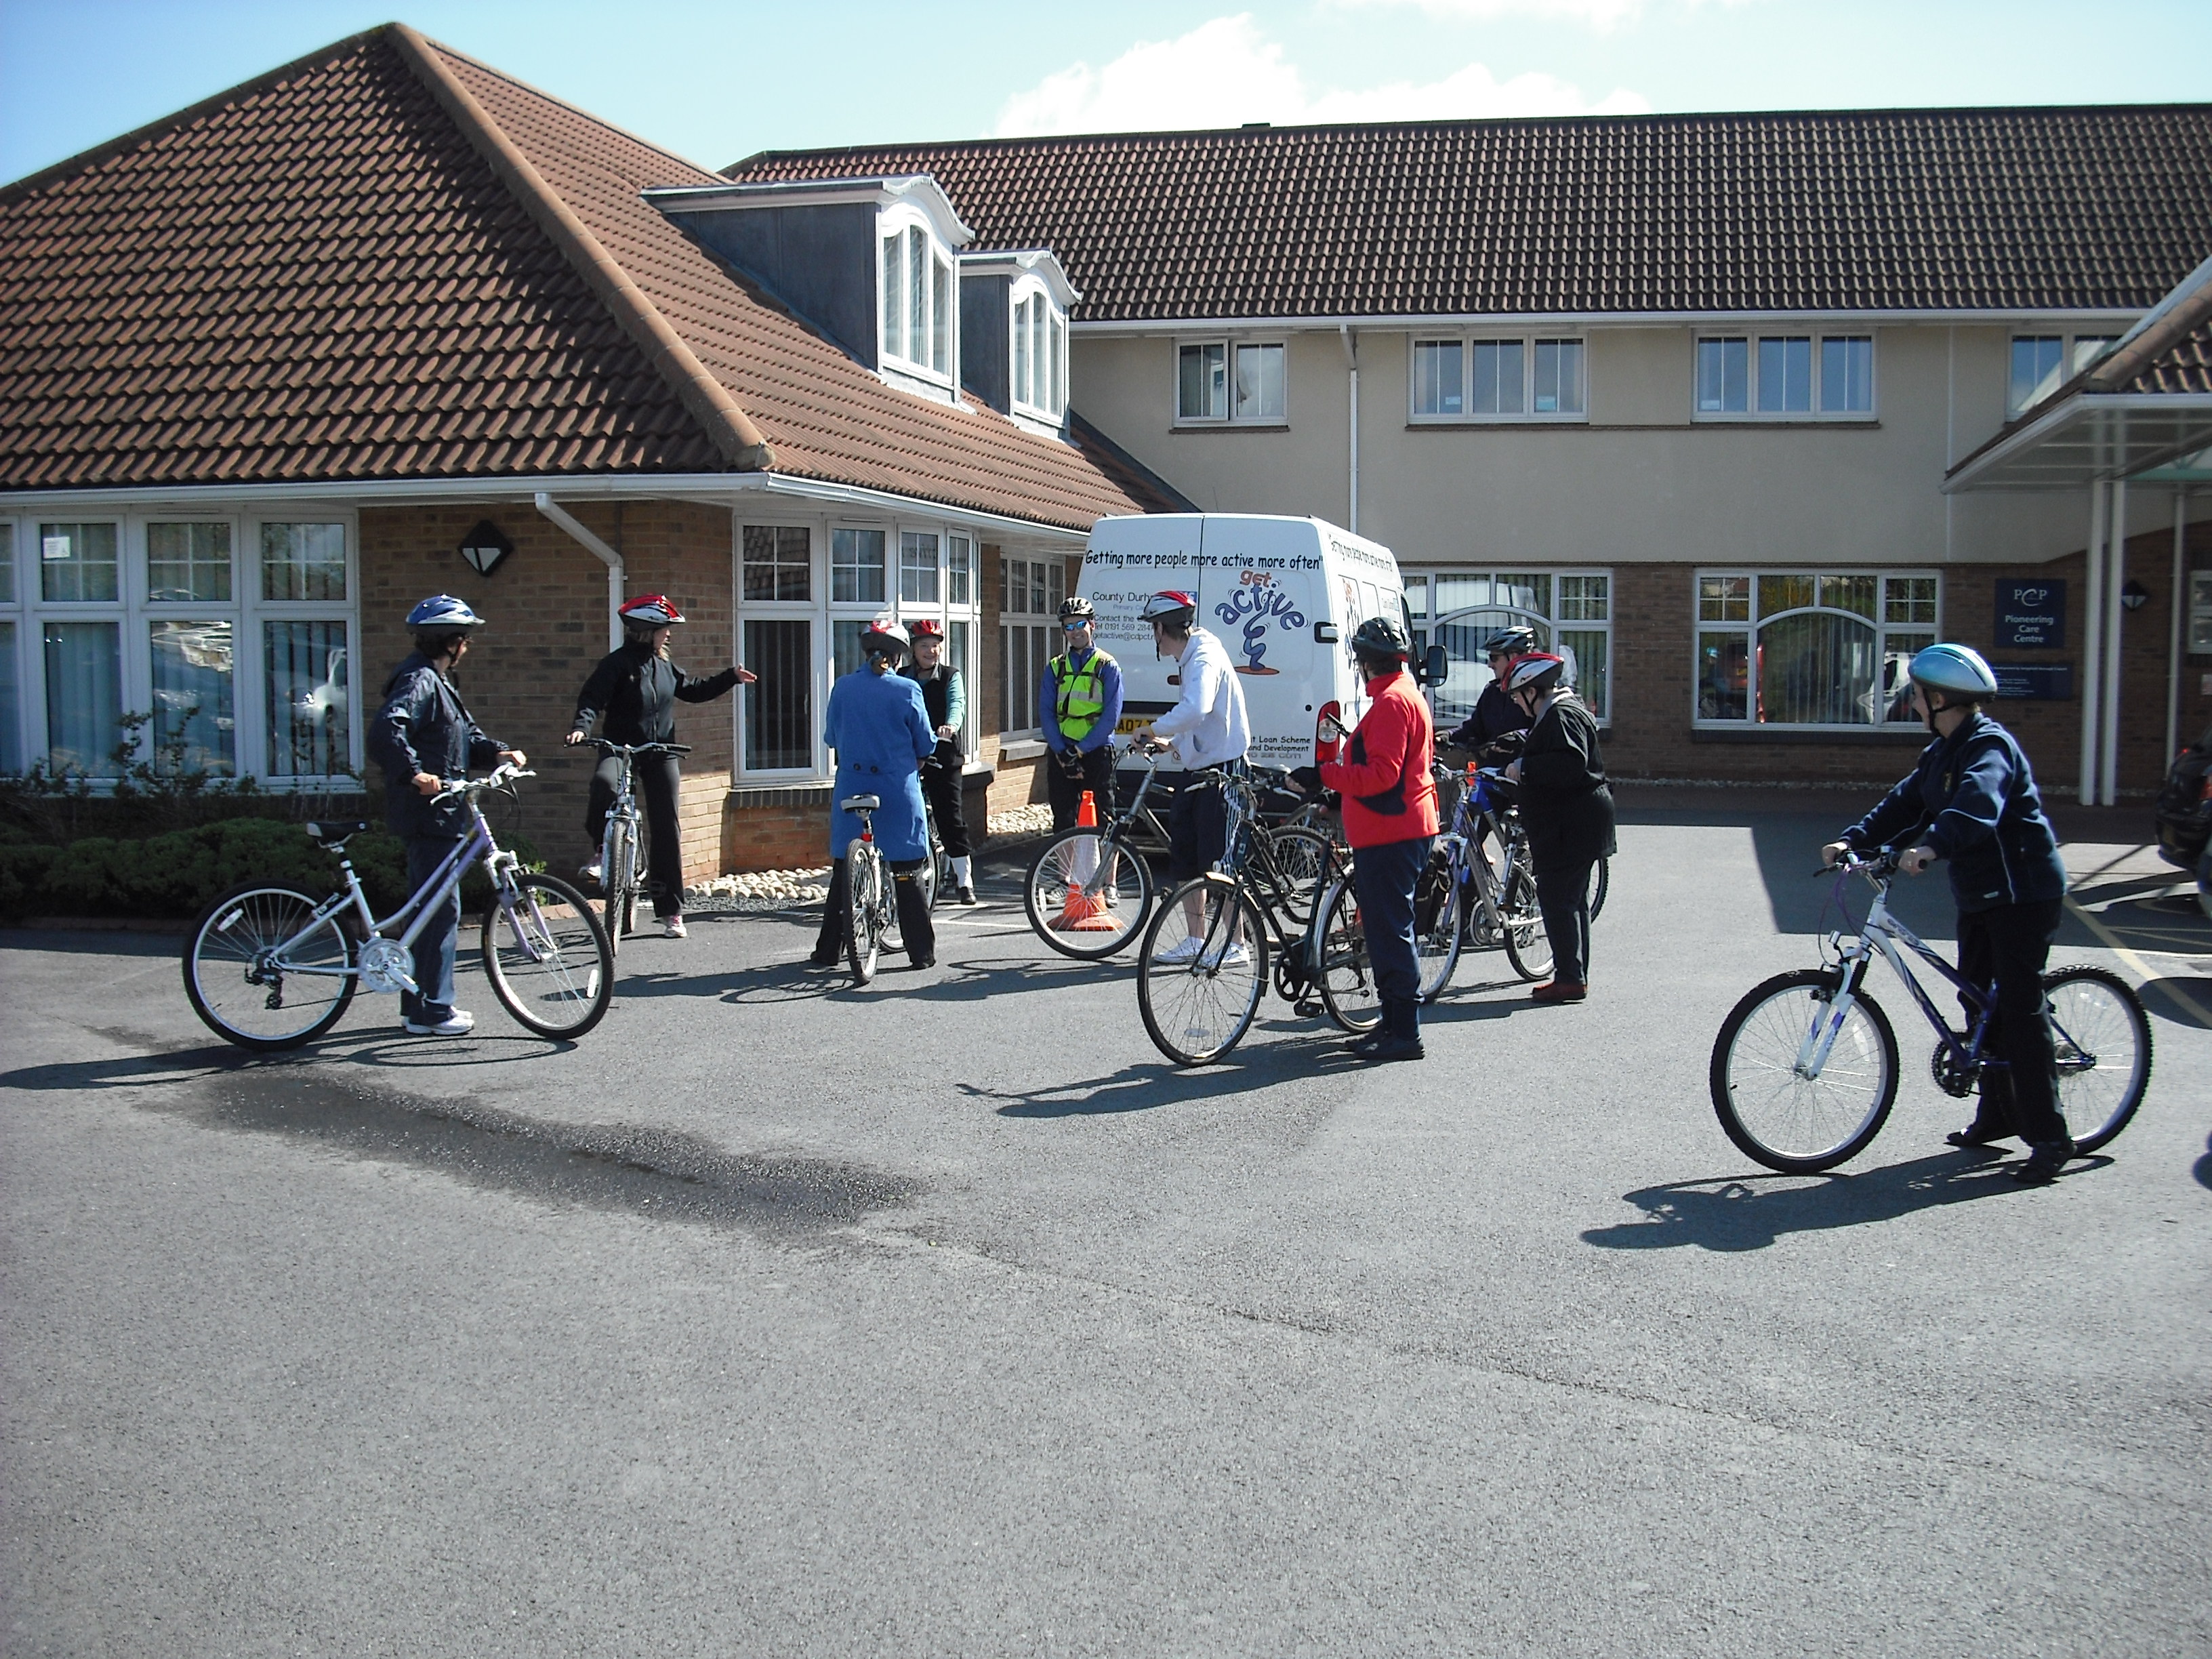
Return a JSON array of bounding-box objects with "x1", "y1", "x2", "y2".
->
[{"x1": 1137, "y1": 770, "x2": 1382, "y2": 1066}]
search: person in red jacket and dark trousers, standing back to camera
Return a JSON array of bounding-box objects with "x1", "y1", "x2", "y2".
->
[{"x1": 1321, "y1": 617, "x2": 1435, "y2": 1059}]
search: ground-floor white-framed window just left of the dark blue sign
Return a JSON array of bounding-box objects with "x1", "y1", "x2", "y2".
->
[{"x1": 1692, "y1": 571, "x2": 1938, "y2": 728}]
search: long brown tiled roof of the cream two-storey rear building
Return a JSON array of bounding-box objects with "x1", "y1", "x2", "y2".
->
[{"x1": 728, "y1": 104, "x2": 2212, "y2": 321}]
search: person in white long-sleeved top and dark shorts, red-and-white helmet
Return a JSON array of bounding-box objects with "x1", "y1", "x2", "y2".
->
[{"x1": 1139, "y1": 590, "x2": 1252, "y2": 962}]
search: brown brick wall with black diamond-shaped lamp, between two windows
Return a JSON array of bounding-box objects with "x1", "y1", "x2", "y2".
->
[{"x1": 361, "y1": 502, "x2": 735, "y2": 880}]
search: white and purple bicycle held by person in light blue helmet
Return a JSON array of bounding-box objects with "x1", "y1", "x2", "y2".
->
[{"x1": 1710, "y1": 852, "x2": 2150, "y2": 1174}]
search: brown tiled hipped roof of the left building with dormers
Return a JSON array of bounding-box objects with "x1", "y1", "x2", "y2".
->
[{"x1": 0, "y1": 24, "x2": 1168, "y2": 527}]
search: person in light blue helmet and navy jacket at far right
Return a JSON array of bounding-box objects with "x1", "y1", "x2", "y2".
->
[{"x1": 1820, "y1": 646, "x2": 2072, "y2": 1183}]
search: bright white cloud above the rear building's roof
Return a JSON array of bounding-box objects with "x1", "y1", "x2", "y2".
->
[{"x1": 996, "y1": 14, "x2": 1650, "y2": 137}]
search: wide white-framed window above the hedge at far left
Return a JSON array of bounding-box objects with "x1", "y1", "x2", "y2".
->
[{"x1": 0, "y1": 518, "x2": 361, "y2": 785}]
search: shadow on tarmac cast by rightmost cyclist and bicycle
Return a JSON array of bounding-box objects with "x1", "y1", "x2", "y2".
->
[{"x1": 1582, "y1": 1153, "x2": 2112, "y2": 1250}]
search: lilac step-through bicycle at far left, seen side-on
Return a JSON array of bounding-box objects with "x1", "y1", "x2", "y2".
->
[{"x1": 184, "y1": 763, "x2": 615, "y2": 1050}]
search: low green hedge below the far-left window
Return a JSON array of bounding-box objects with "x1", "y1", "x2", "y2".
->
[{"x1": 0, "y1": 819, "x2": 544, "y2": 918}]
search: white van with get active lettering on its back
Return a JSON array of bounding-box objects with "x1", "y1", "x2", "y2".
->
[{"x1": 1078, "y1": 513, "x2": 1411, "y2": 768}]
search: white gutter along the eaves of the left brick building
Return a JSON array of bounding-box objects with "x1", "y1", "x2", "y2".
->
[{"x1": 0, "y1": 473, "x2": 1090, "y2": 546}]
